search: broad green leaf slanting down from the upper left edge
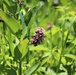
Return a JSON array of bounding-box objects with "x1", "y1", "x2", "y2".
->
[{"x1": 0, "y1": 11, "x2": 21, "y2": 33}]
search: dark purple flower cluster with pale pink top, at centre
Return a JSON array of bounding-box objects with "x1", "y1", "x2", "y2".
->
[{"x1": 30, "y1": 27, "x2": 44, "y2": 46}]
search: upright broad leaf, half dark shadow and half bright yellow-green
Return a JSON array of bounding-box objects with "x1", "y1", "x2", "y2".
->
[{"x1": 14, "y1": 39, "x2": 29, "y2": 60}]
